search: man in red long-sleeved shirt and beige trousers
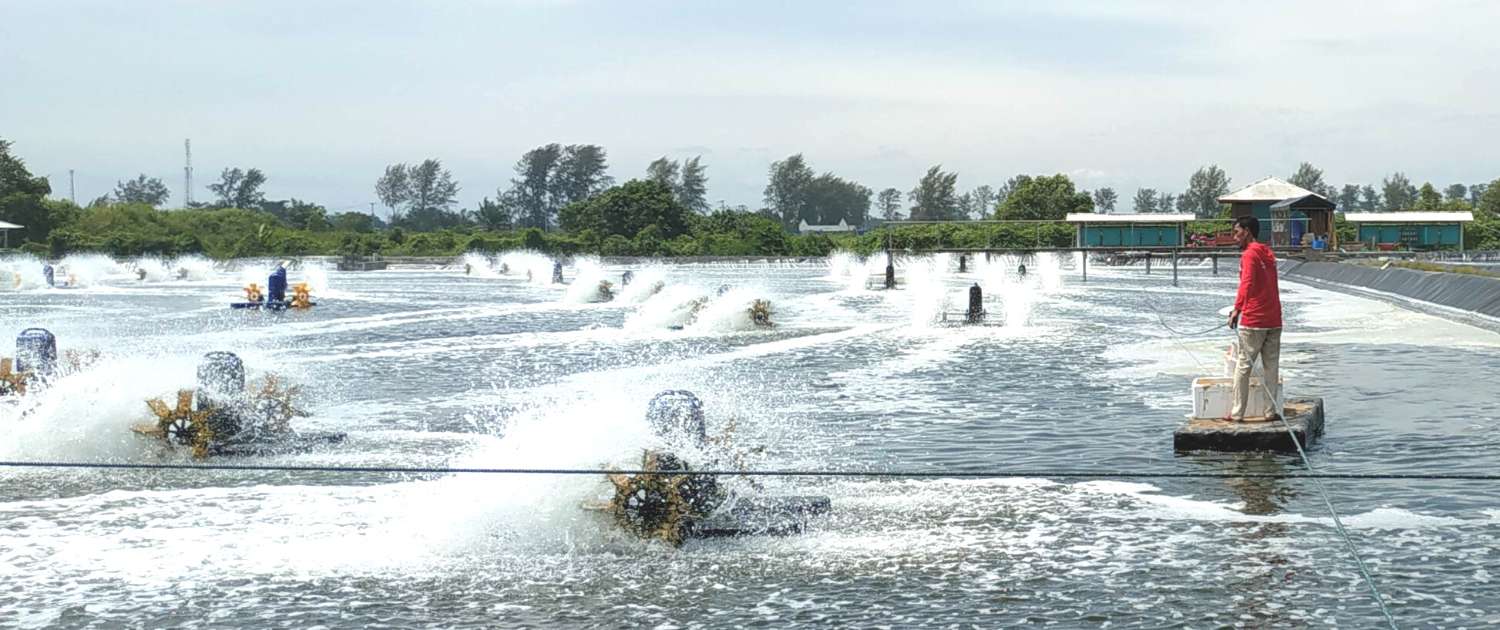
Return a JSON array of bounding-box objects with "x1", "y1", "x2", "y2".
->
[{"x1": 1227, "y1": 216, "x2": 1281, "y2": 422}]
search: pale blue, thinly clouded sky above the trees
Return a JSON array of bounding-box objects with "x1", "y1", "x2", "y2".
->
[{"x1": 0, "y1": 0, "x2": 1500, "y2": 212}]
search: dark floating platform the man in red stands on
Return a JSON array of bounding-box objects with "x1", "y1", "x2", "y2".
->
[{"x1": 1172, "y1": 398, "x2": 1323, "y2": 453}]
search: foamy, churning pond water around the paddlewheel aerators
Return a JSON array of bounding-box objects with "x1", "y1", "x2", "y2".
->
[{"x1": 0, "y1": 255, "x2": 1500, "y2": 629}]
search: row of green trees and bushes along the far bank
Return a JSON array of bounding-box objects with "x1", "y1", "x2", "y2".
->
[{"x1": 0, "y1": 134, "x2": 1500, "y2": 257}]
